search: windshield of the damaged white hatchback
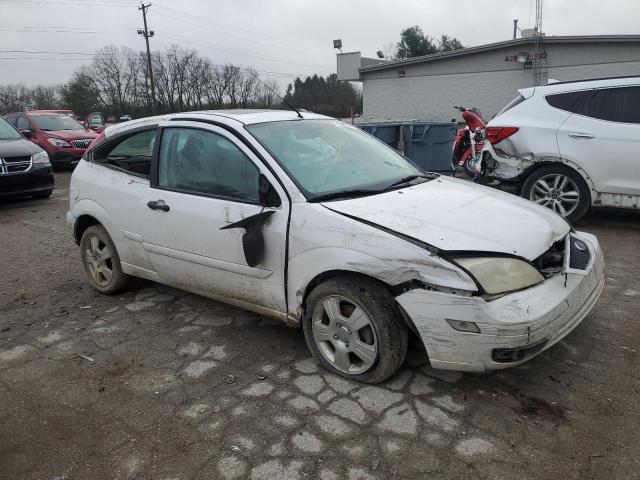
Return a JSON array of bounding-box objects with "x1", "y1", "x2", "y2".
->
[{"x1": 246, "y1": 119, "x2": 425, "y2": 200}]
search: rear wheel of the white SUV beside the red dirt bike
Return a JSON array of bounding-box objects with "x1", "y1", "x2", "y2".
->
[{"x1": 520, "y1": 165, "x2": 591, "y2": 223}]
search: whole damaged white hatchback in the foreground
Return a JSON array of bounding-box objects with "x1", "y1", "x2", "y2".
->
[{"x1": 67, "y1": 111, "x2": 604, "y2": 383}]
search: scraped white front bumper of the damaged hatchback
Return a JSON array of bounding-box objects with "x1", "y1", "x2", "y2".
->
[{"x1": 397, "y1": 233, "x2": 604, "y2": 372}]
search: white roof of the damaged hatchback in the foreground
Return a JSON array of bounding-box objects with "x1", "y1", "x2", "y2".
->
[{"x1": 105, "y1": 109, "x2": 331, "y2": 136}]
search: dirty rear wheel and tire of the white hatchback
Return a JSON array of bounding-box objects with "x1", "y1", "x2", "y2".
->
[{"x1": 80, "y1": 225, "x2": 129, "y2": 295}]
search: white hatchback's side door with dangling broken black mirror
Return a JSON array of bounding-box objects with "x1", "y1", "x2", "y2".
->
[{"x1": 141, "y1": 122, "x2": 289, "y2": 313}]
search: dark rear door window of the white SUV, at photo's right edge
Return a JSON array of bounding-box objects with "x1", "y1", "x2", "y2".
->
[{"x1": 588, "y1": 87, "x2": 640, "y2": 123}]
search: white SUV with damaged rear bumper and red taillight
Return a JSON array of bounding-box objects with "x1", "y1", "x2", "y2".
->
[{"x1": 481, "y1": 77, "x2": 640, "y2": 222}]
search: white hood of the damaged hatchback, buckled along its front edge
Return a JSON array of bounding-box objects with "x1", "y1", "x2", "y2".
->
[{"x1": 323, "y1": 177, "x2": 570, "y2": 260}]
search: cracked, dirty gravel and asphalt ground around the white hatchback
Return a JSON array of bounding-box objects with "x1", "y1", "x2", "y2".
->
[{"x1": 0, "y1": 173, "x2": 640, "y2": 480}]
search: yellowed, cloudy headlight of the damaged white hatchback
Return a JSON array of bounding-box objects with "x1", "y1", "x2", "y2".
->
[{"x1": 454, "y1": 257, "x2": 544, "y2": 295}]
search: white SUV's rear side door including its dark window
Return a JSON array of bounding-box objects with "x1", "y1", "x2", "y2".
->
[{"x1": 557, "y1": 86, "x2": 640, "y2": 195}]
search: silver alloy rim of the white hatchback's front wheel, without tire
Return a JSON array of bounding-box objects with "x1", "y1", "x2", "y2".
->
[{"x1": 312, "y1": 295, "x2": 378, "y2": 374}]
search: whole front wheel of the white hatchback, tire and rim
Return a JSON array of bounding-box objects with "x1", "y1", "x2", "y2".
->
[{"x1": 302, "y1": 275, "x2": 408, "y2": 383}]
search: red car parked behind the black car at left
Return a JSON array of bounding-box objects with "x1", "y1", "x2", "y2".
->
[{"x1": 5, "y1": 110, "x2": 97, "y2": 167}]
